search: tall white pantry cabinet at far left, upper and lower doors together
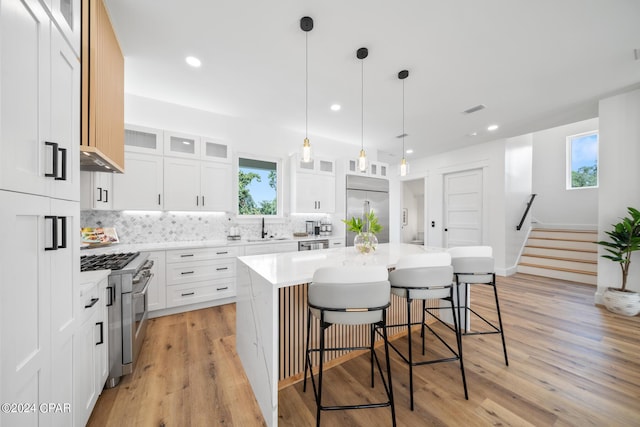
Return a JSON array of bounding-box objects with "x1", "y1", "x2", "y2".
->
[{"x1": 0, "y1": 0, "x2": 80, "y2": 427}]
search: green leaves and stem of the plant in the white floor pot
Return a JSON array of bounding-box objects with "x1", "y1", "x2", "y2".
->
[{"x1": 595, "y1": 207, "x2": 640, "y2": 291}]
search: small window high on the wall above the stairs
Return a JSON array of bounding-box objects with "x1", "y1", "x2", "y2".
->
[{"x1": 567, "y1": 131, "x2": 598, "y2": 189}]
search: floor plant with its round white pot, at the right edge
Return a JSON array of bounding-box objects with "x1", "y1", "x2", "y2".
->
[{"x1": 596, "y1": 207, "x2": 640, "y2": 316}]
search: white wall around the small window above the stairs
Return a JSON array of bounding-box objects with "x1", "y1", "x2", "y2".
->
[{"x1": 531, "y1": 118, "x2": 605, "y2": 230}]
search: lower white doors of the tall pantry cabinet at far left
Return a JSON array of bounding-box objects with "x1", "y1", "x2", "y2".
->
[{"x1": 0, "y1": 190, "x2": 80, "y2": 425}]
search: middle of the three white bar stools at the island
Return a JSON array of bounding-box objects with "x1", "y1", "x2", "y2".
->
[{"x1": 387, "y1": 252, "x2": 469, "y2": 411}]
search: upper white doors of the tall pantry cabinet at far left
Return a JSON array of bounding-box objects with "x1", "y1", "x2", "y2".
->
[{"x1": 0, "y1": 0, "x2": 80, "y2": 201}]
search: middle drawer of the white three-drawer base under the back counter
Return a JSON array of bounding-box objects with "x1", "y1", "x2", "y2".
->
[{"x1": 166, "y1": 259, "x2": 236, "y2": 285}]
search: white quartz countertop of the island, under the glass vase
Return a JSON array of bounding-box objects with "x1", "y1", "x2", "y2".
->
[{"x1": 238, "y1": 243, "x2": 444, "y2": 288}]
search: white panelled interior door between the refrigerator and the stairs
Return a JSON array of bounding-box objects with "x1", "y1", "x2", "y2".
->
[{"x1": 443, "y1": 169, "x2": 483, "y2": 248}]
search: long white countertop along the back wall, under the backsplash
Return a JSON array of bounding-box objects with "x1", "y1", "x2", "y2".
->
[{"x1": 80, "y1": 236, "x2": 344, "y2": 255}]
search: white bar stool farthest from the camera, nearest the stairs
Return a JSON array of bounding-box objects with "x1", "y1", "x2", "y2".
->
[{"x1": 448, "y1": 246, "x2": 509, "y2": 366}]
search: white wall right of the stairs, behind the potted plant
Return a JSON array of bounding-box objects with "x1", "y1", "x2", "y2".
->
[{"x1": 595, "y1": 90, "x2": 640, "y2": 303}]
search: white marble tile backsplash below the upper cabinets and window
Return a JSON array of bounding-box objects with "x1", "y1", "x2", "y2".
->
[{"x1": 80, "y1": 210, "x2": 340, "y2": 244}]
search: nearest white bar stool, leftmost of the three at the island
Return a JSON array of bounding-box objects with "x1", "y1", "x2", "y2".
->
[{"x1": 303, "y1": 266, "x2": 396, "y2": 427}]
